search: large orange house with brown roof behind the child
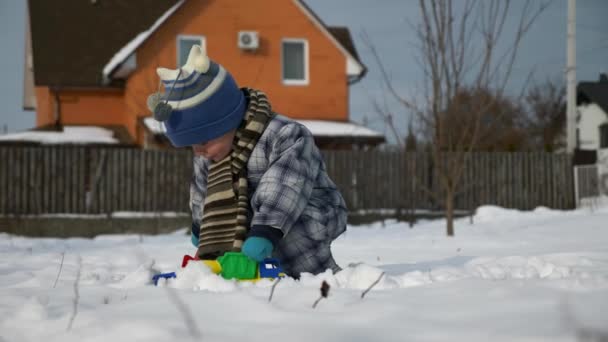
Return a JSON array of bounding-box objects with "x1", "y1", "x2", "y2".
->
[{"x1": 24, "y1": 0, "x2": 385, "y2": 148}]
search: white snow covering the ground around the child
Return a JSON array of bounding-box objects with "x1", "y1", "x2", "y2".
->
[{"x1": 0, "y1": 206, "x2": 608, "y2": 342}]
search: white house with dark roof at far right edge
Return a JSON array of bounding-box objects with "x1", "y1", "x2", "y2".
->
[{"x1": 576, "y1": 74, "x2": 608, "y2": 164}]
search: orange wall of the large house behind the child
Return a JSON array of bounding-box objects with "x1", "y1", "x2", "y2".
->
[{"x1": 37, "y1": 0, "x2": 348, "y2": 144}]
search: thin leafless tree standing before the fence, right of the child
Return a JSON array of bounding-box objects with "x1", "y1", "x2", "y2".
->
[{"x1": 364, "y1": 0, "x2": 551, "y2": 236}]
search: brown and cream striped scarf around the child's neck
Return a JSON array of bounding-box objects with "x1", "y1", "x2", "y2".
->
[{"x1": 197, "y1": 88, "x2": 274, "y2": 259}]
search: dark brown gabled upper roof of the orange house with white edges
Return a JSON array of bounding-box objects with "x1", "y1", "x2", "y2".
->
[{"x1": 29, "y1": 0, "x2": 367, "y2": 87}]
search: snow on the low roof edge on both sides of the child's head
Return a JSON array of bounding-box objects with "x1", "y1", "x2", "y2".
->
[{"x1": 144, "y1": 117, "x2": 384, "y2": 137}]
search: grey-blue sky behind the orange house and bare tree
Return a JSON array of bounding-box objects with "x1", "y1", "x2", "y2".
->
[{"x1": 0, "y1": 0, "x2": 608, "y2": 140}]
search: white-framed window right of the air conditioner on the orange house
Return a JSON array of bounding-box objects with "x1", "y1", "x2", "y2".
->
[{"x1": 281, "y1": 39, "x2": 308, "y2": 85}]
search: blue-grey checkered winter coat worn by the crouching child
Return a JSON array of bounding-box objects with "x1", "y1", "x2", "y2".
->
[{"x1": 190, "y1": 115, "x2": 347, "y2": 276}]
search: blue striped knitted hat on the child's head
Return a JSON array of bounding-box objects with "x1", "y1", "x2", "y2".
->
[{"x1": 148, "y1": 45, "x2": 245, "y2": 147}]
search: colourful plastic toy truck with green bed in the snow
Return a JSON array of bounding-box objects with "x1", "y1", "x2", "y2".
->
[{"x1": 152, "y1": 252, "x2": 285, "y2": 285}]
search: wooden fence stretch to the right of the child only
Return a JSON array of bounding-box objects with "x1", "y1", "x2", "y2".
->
[{"x1": 324, "y1": 151, "x2": 574, "y2": 210}]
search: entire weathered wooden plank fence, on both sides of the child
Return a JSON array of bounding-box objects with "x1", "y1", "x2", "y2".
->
[{"x1": 0, "y1": 146, "x2": 574, "y2": 215}]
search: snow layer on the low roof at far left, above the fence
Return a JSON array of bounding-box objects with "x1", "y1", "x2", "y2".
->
[{"x1": 0, "y1": 126, "x2": 119, "y2": 145}]
